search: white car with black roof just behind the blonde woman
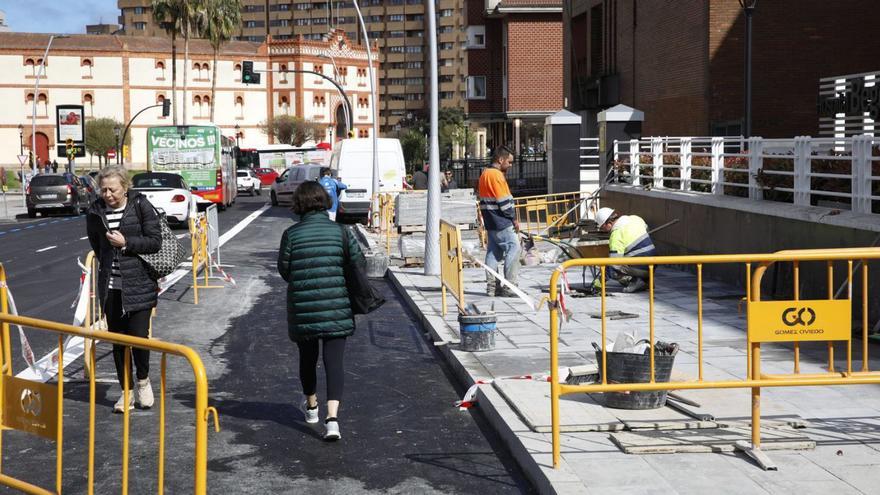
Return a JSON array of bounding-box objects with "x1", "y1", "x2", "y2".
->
[{"x1": 131, "y1": 172, "x2": 197, "y2": 225}]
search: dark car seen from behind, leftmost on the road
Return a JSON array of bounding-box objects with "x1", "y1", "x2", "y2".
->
[{"x1": 25, "y1": 173, "x2": 89, "y2": 218}]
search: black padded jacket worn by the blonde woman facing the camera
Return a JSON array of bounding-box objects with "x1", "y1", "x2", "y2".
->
[{"x1": 86, "y1": 190, "x2": 162, "y2": 312}]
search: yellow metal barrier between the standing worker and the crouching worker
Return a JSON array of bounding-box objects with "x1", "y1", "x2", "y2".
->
[{"x1": 513, "y1": 192, "x2": 590, "y2": 237}]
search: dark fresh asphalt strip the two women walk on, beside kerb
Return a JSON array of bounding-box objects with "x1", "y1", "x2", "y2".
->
[{"x1": 3, "y1": 193, "x2": 532, "y2": 494}]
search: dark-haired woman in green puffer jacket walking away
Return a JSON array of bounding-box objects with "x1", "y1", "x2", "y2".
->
[{"x1": 278, "y1": 182, "x2": 364, "y2": 441}]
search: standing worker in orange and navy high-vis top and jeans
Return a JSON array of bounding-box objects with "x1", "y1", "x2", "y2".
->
[{"x1": 479, "y1": 146, "x2": 522, "y2": 297}]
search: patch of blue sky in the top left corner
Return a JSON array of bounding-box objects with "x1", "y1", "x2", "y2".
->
[{"x1": 0, "y1": 0, "x2": 119, "y2": 33}]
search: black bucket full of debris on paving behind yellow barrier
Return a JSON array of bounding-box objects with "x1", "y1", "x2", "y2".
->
[{"x1": 596, "y1": 351, "x2": 675, "y2": 409}]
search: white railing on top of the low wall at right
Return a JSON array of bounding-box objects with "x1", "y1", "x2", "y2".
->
[{"x1": 614, "y1": 136, "x2": 880, "y2": 213}]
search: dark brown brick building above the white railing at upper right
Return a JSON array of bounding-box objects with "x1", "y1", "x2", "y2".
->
[{"x1": 564, "y1": 0, "x2": 880, "y2": 137}]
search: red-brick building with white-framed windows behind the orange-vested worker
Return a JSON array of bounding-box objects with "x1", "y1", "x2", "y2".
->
[{"x1": 467, "y1": 0, "x2": 563, "y2": 156}]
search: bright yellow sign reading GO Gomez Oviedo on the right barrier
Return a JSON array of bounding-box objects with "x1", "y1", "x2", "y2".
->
[{"x1": 748, "y1": 299, "x2": 852, "y2": 342}]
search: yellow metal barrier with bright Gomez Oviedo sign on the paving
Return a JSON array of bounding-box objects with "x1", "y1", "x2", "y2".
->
[{"x1": 549, "y1": 248, "x2": 880, "y2": 468}]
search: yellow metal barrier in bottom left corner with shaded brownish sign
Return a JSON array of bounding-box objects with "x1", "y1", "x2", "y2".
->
[{"x1": 0, "y1": 263, "x2": 220, "y2": 494}]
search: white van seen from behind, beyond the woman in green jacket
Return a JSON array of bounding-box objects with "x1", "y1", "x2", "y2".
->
[{"x1": 330, "y1": 138, "x2": 406, "y2": 219}]
